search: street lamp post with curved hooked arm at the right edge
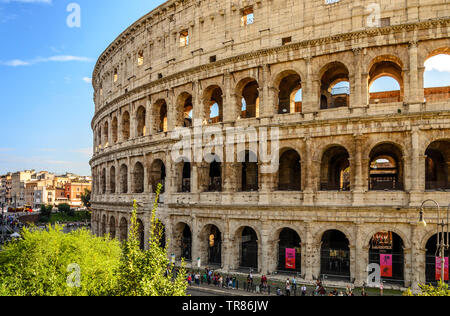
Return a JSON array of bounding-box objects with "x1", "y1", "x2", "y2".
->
[{"x1": 419, "y1": 199, "x2": 450, "y2": 282}]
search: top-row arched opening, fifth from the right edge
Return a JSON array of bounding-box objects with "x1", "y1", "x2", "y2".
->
[{"x1": 236, "y1": 77, "x2": 260, "y2": 118}]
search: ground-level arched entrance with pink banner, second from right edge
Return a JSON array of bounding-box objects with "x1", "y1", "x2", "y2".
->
[{"x1": 369, "y1": 231, "x2": 405, "y2": 285}]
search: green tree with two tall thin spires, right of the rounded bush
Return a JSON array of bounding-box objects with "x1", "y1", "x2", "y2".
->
[{"x1": 117, "y1": 184, "x2": 187, "y2": 296}]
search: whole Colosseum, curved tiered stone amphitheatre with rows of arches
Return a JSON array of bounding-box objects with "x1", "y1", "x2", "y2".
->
[{"x1": 90, "y1": 0, "x2": 450, "y2": 288}]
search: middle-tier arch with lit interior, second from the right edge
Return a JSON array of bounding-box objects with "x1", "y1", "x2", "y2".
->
[{"x1": 368, "y1": 142, "x2": 405, "y2": 191}]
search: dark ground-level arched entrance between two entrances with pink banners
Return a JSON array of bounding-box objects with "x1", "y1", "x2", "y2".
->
[{"x1": 320, "y1": 230, "x2": 350, "y2": 281}]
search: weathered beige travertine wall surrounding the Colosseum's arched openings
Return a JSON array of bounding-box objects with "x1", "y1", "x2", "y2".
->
[{"x1": 91, "y1": 0, "x2": 450, "y2": 287}]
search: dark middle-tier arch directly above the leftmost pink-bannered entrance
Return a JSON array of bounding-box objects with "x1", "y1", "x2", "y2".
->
[{"x1": 278, "y1": 148, "x2": 302, "y2": 191}]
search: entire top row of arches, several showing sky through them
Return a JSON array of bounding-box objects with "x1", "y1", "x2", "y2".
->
[{"x1": 95, "y1": 49, "x2": 450, "y2": 148}]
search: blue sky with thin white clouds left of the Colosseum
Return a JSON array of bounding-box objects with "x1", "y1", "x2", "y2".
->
[{"x1": 0, "y1": 0, "x2": 450, "y2": 175}]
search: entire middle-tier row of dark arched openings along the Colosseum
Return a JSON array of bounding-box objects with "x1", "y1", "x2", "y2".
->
[{"x1": 94, "y1": 140, "x2": 450, "y2": 194}]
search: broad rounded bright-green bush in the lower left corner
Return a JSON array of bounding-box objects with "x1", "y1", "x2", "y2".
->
[{"x1": 0, "y1": 226, "x2": 121, "y2": 296}]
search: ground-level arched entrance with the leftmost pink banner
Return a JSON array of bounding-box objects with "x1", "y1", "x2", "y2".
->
[{"x1": 277, "y1": 228, "x2": 302, "y2": 273}]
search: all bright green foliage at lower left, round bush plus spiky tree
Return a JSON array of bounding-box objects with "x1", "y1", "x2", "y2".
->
[{"x1": 0, "y1": 186, "x2": 187, "y2": 296}]
